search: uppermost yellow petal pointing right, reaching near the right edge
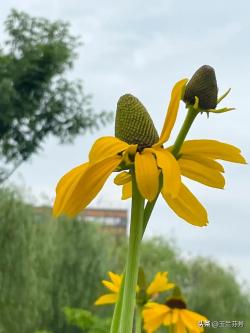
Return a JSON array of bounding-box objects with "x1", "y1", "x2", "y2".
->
[{"x1": 181, "y1": 140, "x2": 246, "y2": 164}]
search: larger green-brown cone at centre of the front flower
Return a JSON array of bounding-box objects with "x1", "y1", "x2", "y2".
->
[{"x1": 115, "y1": 94, "x2": 159, "y2": 149}]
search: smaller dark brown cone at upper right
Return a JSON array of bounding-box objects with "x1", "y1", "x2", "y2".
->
[{"x1": 183, "y1": 65, "x2": 218, "y2": 110}]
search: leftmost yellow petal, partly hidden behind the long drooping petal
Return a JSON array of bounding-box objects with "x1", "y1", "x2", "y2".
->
[{"x1": 53, "y1": 163, "x2": 89, "y2": 216}]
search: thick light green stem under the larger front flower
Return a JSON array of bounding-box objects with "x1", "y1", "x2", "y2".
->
[{"x1": 120, "y1": 173, "x2": 144, "y2": 333}]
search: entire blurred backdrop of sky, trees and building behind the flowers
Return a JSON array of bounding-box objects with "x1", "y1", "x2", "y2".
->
[{"x1": 0, "y1": 0, "x2": 250, "y2": 333}]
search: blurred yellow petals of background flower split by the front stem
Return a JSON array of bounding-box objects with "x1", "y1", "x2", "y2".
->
[{"x1": 95, "y1": 272, "x2": 175, "y2": 305}]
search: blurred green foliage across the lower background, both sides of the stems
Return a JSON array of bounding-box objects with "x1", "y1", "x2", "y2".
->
[{"x1": 0, "y1": 189, "x2": 250, "y2": 333}]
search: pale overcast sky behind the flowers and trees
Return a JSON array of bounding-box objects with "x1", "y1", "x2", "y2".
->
[{"x1": 0, "y1": 0, "x2": 250, "y2": 281}]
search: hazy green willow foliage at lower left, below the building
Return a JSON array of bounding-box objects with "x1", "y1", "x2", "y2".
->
[{"x1": 0, "y1": 189, "x2": 114, "y2": 333}]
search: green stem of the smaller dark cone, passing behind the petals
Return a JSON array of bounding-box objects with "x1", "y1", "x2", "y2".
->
[{"x1": 142, "y1": 106, "x2": 198, "y2": 236}]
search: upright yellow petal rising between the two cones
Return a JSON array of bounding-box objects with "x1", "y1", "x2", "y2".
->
[{"x1": 156, "y1": 79, "x2": 188, "y2": 146}]
